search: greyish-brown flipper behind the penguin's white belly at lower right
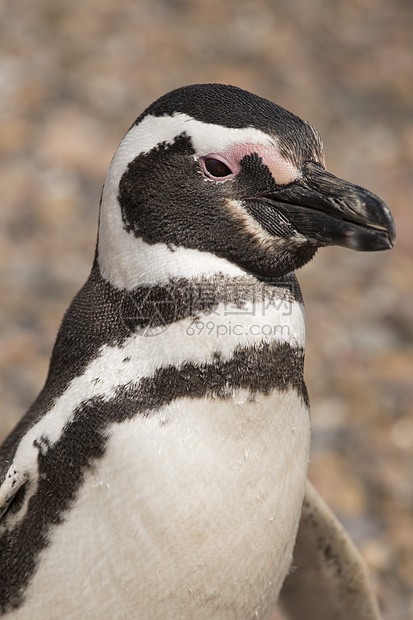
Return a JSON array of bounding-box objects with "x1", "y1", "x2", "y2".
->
[{"x1": 279, "y1": 481, "x2": 381, "y2": 620}]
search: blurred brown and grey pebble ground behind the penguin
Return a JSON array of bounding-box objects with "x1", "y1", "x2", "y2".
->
[{"x1": 0, "y1": 0, "x2": 413, "y2": 620}]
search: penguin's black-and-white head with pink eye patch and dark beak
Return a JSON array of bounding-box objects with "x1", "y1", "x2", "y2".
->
[{"x1": 98, "y1": 84, "x2": 395, "y2": 280}]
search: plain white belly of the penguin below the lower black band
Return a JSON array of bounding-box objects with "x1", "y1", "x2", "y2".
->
[{"x1": 12, "y1": 390, "x2": 309, "y2": 620}]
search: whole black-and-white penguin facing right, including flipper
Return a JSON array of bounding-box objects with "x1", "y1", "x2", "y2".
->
[{"x1": 0, "y1": 84, "x2": 395, "y2": 620}]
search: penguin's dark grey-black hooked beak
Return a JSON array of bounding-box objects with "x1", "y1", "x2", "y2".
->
[{"x1": 260, "y1": 162, "x2": 396, "y2": 251}]
